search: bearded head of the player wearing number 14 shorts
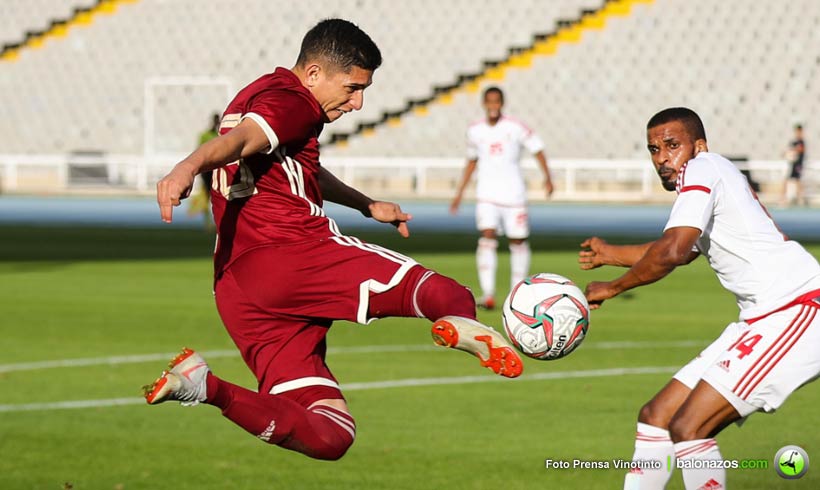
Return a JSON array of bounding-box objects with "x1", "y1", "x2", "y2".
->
[{"x1": 646, "y1": 107, "x2": 709, "y2": 191}]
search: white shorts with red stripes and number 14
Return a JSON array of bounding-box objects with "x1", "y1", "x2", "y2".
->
[{"x1": 675, "y1": 294, "x2": 820, "y2": 417}]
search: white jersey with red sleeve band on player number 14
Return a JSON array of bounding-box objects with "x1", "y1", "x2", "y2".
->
[{"x1": 664, "y1": 152, "x2": 820, "y2": 320}]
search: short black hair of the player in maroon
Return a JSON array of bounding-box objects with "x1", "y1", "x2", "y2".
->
[{"x1": 296, "y1": 19, "x2": 382, "y2": 72}]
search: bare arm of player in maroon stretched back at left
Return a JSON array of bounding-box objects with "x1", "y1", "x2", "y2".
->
[{"x1": 157, "y1": 119, "x2": 270, "y2": 223}]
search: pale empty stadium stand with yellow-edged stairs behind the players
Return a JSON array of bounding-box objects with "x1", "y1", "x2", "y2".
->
[{"x1": 0, "y1": 0, "x2": 820, "y2": 201}]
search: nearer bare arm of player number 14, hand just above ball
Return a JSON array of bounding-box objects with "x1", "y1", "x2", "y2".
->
[{"x1": 585, "y1": 226, "x2": 701, "y2": 309}]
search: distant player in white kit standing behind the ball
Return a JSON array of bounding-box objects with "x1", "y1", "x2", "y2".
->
[{"x1": 450, "y1": 87, "x2": 553, "y2": 309}]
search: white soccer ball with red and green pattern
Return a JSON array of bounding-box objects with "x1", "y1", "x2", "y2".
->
[{"x1": 501, "y1": 272, "x2": 589, "y2": 360}]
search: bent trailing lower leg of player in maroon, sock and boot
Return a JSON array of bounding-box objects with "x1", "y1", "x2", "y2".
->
[{"x1": 143, "y1": 348, "x2": 356, "y2": 460}]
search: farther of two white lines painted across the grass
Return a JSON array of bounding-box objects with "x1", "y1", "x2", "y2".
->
[{"x1": 0, "y1": 340, "x2": 709, "y2": 373}]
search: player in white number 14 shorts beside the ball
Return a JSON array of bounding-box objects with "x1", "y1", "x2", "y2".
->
[{"x1": 579, "y1": 108, "x2": 820, "y2": 489}]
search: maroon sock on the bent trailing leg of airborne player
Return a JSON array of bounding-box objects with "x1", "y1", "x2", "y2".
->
[{"x1": 206, "y1": 373, "x2": 356, "y2": 460}]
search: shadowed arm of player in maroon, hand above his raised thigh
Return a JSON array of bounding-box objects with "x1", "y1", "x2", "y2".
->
[{"x1": 319, "y1": 167, "x2": 413, "y2": 238}]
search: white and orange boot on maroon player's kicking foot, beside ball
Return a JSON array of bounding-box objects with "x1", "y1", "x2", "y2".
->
[{"x1": 432, "y1": 316, "x2": 524, "y2": 378}]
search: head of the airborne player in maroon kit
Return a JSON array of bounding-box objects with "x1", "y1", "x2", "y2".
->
[{"x1": 294, "y1": 19, "x2": 382, "y2": 122}]
